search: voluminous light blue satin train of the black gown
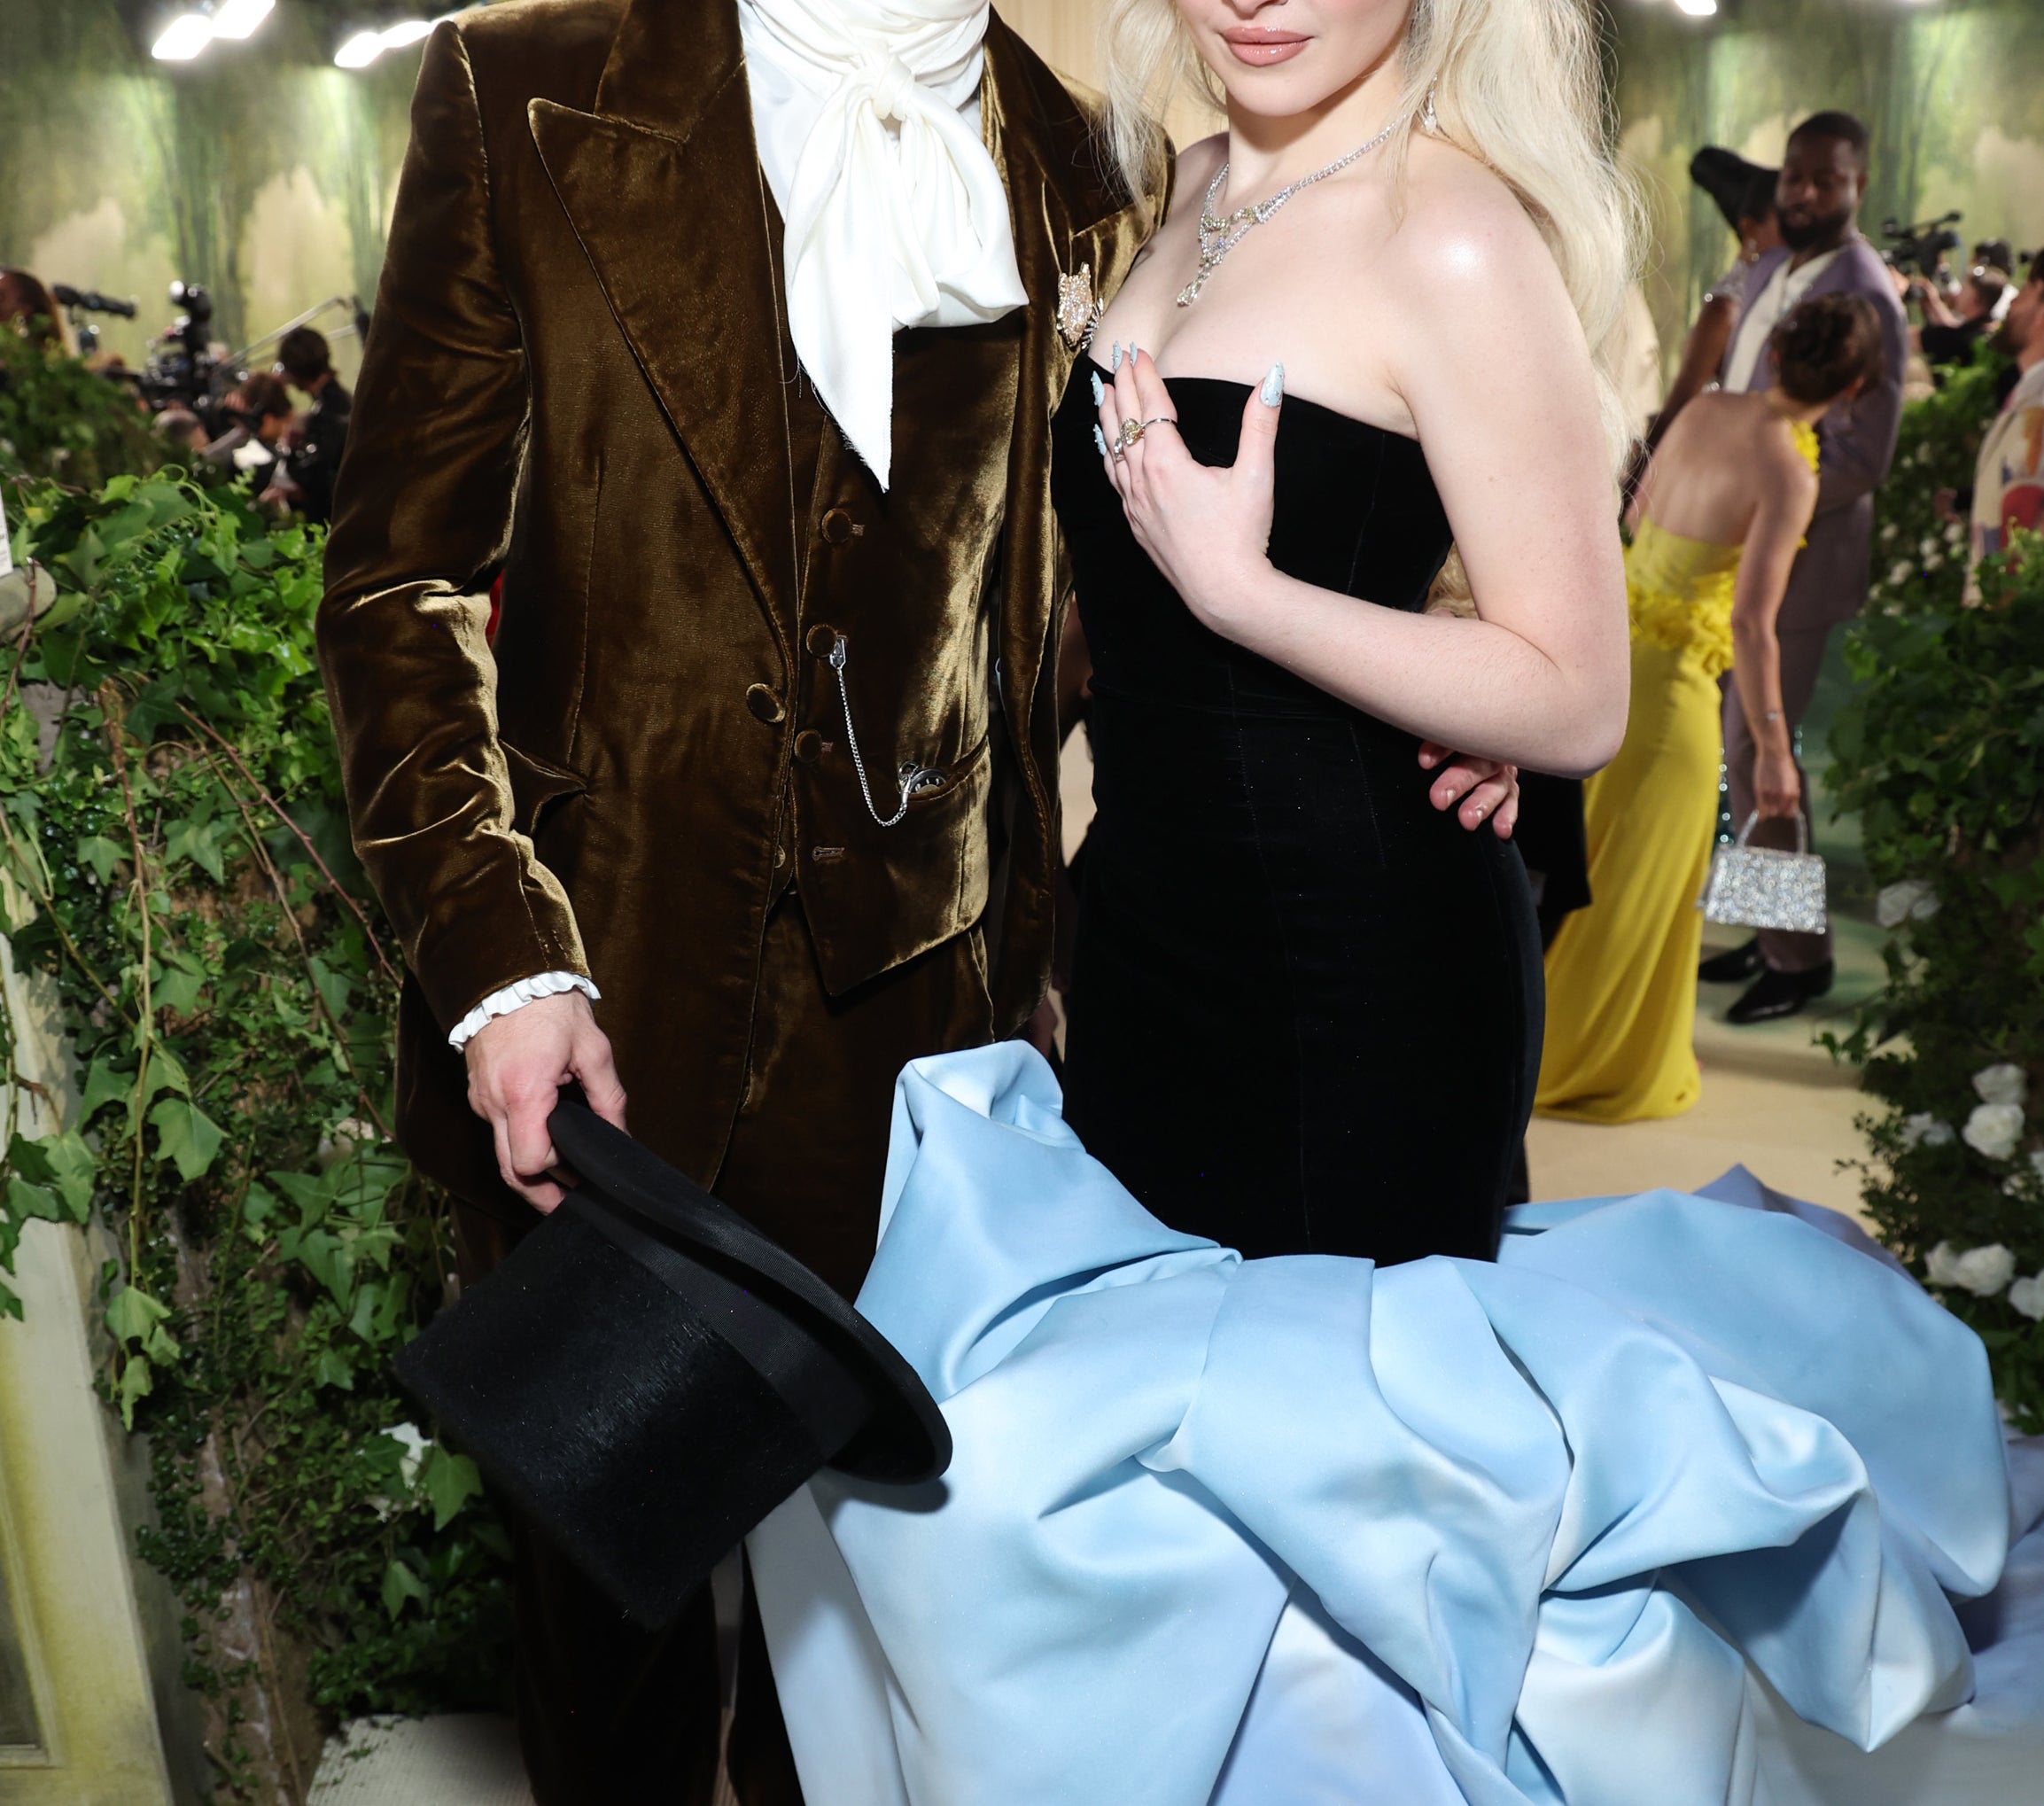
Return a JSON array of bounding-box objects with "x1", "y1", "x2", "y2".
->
[{"x1": 750, "y1": 1043, "x2": 2044, "y2": 1806}]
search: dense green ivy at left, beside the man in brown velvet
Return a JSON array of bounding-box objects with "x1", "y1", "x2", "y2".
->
[{"x1": 0, "y1": 458, "x2": 509, "y2": 1800}]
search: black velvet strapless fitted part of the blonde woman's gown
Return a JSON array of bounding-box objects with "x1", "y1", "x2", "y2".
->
[{"x1": 1051, "y1": 358, "x2": 1543, "y2": 1264}]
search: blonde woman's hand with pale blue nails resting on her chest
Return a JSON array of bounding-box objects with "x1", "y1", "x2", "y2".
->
[{"x1": 1093, "y1": 347, "x2": 1284, "y2": 638}]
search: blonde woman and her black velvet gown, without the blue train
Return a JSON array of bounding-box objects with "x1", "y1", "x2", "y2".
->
[{"x1": 1053, "y1": 0, "x2": 1629, "y2": 1264}]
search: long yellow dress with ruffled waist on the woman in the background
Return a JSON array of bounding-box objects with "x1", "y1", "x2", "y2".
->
[{"x1": 1533, "y1": 421, "x2": 1817, "y2": 1123}]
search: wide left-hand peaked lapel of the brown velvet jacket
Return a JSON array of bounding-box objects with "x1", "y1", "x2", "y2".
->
[{"x1": 527, "y1": 0, "x2": 799, "y2": 649}]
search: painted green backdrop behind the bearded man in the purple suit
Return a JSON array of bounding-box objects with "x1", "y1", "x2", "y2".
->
[{"x1": 1611, "y1": 0, "x2": 2044, "y2": 384}]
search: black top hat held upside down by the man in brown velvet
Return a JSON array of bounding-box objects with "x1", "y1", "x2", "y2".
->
[{"x1": 397, "y1": 1102, "x2": 951, "y2": 1626}]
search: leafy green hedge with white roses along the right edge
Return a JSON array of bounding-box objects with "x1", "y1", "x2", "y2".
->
[{"x1": 1825, "y1": 354, "x2": 2044, "y2": 1432}]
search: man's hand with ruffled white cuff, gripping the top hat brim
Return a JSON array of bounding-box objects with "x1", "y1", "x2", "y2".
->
[{"x1": 462, "y1": 990, "x2": 626, "y2": 1210}]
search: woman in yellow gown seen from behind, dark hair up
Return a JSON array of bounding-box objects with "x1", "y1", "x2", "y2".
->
[{"x1": 1535, "y1": 294, "x2": 1880, "y2": 1123}]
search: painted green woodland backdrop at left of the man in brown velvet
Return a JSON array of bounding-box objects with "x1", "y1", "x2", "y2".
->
[{"x1": 0, "y1": 0, "x2": 419, "y2": 374}]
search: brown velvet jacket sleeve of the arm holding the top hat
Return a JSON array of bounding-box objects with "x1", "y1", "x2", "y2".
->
[{"x1": 319, "y1": 25, "x2": 587, "y2": 1029}]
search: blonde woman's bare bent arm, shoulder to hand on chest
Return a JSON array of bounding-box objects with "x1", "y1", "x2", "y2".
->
[{"x1": 1101, "y1": 175, "x2": 1629, "y2": 777}]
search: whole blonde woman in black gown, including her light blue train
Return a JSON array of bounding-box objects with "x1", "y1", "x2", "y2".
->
[{"x1": 748, "y1": 0, "x2": 2030, "y2": 1806}]
